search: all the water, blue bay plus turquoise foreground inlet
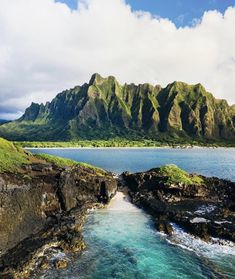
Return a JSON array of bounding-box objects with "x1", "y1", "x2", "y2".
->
[{"x1": 29, "y1": 149, "x2": 235, "y2": 279}]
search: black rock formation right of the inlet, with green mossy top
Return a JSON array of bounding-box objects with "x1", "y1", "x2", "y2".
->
[{"x1": 122, "y1": 166, "x2": 235, "y2": 242}]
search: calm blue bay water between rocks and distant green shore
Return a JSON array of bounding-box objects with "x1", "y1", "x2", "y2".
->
[{"x1": 29, "y1": 148, "x2": 235, "y2": 181}]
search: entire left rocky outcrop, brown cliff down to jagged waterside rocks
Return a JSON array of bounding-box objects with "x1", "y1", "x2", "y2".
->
[{"x1": 0, "y1": 162, "x2": 117, "y2": 278}]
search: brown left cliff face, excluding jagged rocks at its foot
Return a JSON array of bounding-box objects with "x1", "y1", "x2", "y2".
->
[{"x1": 0, "y1": 164, "x2": 116, "y2": 254}]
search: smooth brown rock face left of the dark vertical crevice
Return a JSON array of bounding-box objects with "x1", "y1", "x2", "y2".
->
[{"x1": 0, "y1": 175, "x2": 60, "y2": 254}]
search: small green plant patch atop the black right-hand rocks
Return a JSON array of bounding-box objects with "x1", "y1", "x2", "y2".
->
[{"x1": 159, "y1": 165, "x2": 203, "y2": 185}]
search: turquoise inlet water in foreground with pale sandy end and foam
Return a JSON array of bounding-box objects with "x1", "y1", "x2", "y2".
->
[{"x1": 41, "y1": 196, "x2": 235, "y2": 279}]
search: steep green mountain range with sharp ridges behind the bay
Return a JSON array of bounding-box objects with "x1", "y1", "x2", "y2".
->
[{"x1": 0, "y1": 74, "x2": 235, "y2": 142}]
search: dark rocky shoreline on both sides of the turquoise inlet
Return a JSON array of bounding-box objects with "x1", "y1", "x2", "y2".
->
[{"x1": 0, "y1": 158, "x2": 235, "y2": 279}]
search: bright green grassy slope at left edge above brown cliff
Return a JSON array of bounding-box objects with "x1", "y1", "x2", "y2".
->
[{"x1": 0, "y1": 138, "x2": 30, "y2": 173}]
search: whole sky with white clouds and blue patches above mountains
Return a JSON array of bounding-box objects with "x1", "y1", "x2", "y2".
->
[{"x1": 0, "y1": 0, "x2": 235, "y2": 119}]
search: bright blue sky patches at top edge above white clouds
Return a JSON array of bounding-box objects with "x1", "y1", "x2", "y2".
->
[{"x1": 58, "y1": 0, "x2": 235, "y2": 27}]
